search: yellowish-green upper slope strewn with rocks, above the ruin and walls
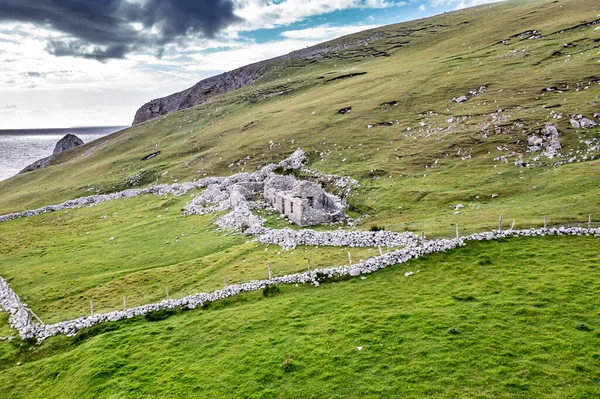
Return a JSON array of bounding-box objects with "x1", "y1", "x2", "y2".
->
[{"x1": 0, "y1": 1, "x2": 600, "y2": 235}]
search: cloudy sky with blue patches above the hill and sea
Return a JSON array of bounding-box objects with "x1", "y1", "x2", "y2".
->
[{"x1": 0, "y1": 0, "x2": 504, "y2": 130}]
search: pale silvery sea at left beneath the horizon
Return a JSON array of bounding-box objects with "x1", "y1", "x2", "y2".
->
[{"x1": 0, "y1": 126, "x2": 127, "y2": 180}]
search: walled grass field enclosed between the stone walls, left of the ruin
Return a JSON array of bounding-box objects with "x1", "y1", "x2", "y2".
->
[{"x1": 0, "y1": 196, "x2": 377, "y2": 324}]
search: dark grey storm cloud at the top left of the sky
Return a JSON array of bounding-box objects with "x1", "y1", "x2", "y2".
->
[{"x1": 0, "y1": 0, "x2": 239, "y2": 61}]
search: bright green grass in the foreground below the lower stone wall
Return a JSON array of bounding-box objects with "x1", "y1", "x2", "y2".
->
[{"x1": 0, "y1": 237, "x2": 600, "y2": 398}]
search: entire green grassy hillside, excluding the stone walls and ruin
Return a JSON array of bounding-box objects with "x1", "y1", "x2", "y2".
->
[{"x1": 0, "y1": 0, "x2": 600, "y2": 398}]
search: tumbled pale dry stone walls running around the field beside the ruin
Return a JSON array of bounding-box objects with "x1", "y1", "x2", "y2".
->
[{"x1": 0, "y1": 150, "x2": 600, "y2": 341}]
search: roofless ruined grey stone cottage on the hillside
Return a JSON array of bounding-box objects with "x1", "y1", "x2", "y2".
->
[{"x1": 263, "y1": 176, "x2": 345, "y2": 226}]
